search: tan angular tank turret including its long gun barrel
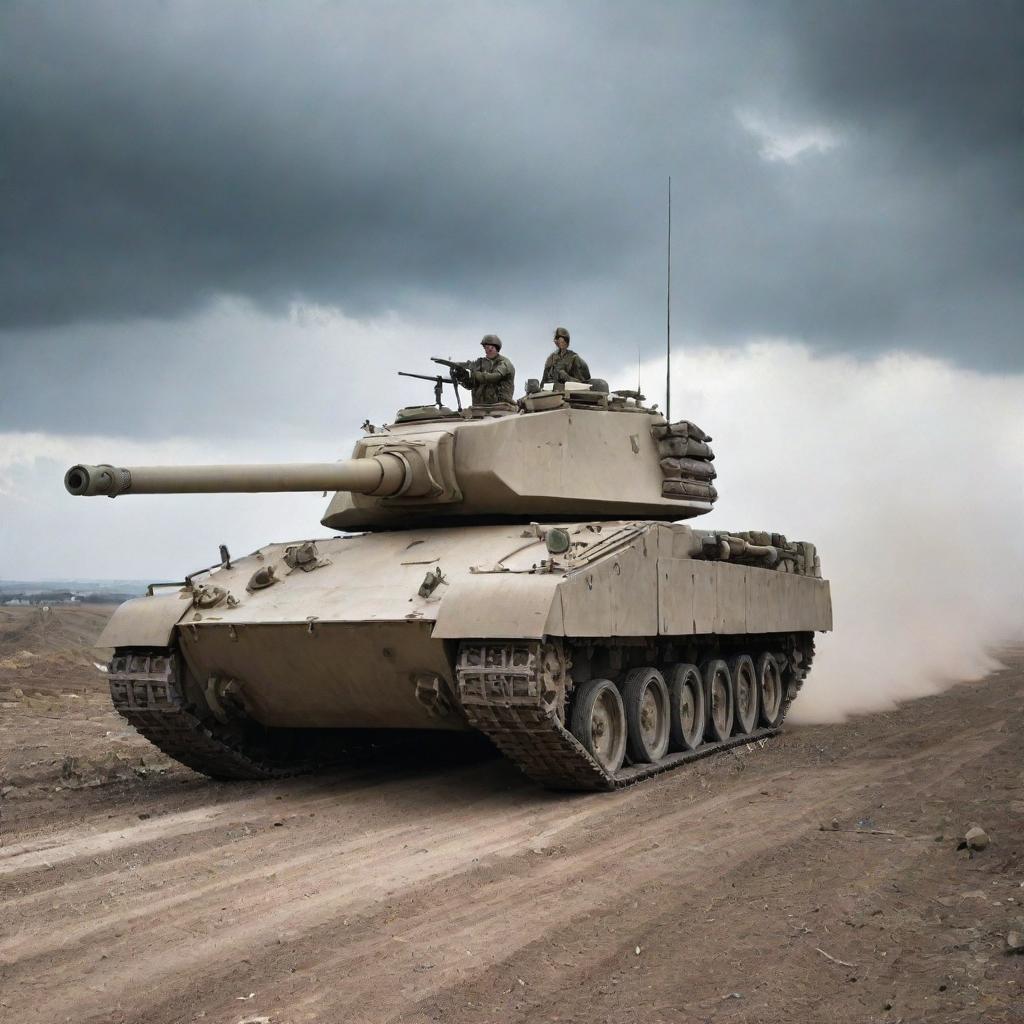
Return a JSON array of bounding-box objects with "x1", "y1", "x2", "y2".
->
[{"x1": 65, "y1": 387, "x2": 717, "y2": 530}]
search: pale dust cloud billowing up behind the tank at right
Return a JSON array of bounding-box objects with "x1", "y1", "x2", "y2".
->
[{"x1": 644, "y1": 341, "x2": 1024, "y2": 722}]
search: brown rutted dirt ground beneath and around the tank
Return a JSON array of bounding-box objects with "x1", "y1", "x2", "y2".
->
[{"x1": 0, "y1": 609, "x2": 1024, "y2": 1024}]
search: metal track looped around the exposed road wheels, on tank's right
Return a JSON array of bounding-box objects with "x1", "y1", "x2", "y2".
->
[{"x1": 456, "y1": 636, "x2": 814, "y2": 792}]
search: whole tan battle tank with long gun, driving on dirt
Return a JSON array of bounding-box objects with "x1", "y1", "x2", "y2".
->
[{"x1": 65, "y1": 378, "x2": 831, "y2": 791}]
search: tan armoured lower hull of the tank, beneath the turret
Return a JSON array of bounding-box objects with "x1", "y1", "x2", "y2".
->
[{"x1": 99, "y1": 521, "x2": 831, "y2": 788}]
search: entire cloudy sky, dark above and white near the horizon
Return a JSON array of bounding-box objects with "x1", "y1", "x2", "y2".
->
[{"x1": 0, "y1": 0, "x2": 1024, "y2": 720}]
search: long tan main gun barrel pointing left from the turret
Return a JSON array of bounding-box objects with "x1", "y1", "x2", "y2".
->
[{"x1": 65, "y1": 453, "x2": 411, "y2": 498}]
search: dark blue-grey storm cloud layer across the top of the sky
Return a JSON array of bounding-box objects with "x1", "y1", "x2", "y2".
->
[{"x1": 0, "y1": 0, "x2": 1024, "y2": 378}]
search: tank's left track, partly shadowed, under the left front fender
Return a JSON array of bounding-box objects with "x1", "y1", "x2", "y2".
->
[{"x1": 106, "y1": 648, "x2": 317, "y2": 779}]
